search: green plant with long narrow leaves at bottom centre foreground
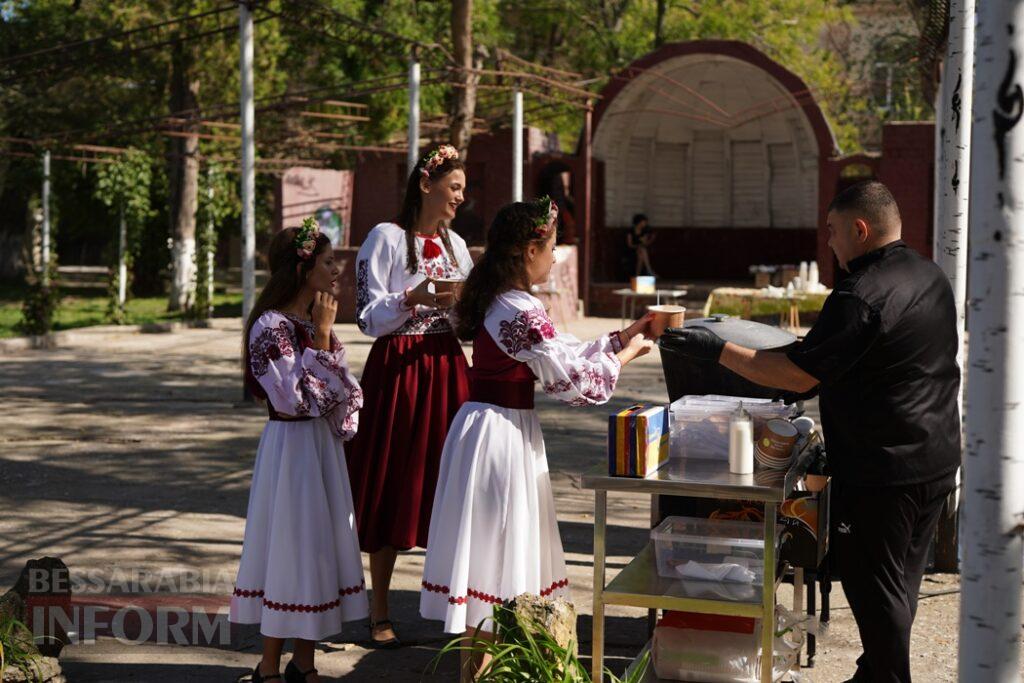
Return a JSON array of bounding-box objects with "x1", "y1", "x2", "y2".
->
[{"x1": 431, "y1": 605, "x2": 649, "y2": 683}]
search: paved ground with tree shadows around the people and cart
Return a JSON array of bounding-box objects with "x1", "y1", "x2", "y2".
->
[{"x1": 0, "y1": 318, "x2": 1007, "y2": 682}]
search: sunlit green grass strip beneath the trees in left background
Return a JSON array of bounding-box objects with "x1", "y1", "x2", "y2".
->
[{"x1": 0, "y1": 285, "x2": 242, "y2": 339}]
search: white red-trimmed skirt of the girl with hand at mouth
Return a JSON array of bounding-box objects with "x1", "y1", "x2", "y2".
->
[{"x1": 229, "y1": 419, "x2": 369, "y2": 640}]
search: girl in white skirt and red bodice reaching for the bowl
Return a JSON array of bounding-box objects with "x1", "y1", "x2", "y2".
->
[{"x1": 420, "y1": 201, "x2": 651, "y2": 680}]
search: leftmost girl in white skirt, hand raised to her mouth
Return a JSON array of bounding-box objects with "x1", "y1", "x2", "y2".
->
[{"x1": 230, "y1": 226, "x2": 368, "y2": 683}]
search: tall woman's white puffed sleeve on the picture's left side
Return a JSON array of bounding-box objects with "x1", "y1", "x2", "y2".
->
[{"x1": 355, "y1": 226, "x2": 413, "y2": 337}]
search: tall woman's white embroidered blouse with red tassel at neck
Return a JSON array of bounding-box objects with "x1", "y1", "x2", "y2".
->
[{"x1": 355, "y1": 223, "x2": 473, "y2": 337}]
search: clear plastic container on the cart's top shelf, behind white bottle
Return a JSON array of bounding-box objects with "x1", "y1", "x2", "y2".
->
[{"x1": 669, "y1": 395, "x2": 794, "y2": 460}]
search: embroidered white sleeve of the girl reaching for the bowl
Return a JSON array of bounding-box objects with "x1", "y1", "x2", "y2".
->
[{"x1": 484, "y1": 295, "x2": 622, "y2": 405}]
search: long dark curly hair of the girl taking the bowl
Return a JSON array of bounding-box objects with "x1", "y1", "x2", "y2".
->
[{"x1": 455, "y1": 198, "x2": 551, "y2": 341}]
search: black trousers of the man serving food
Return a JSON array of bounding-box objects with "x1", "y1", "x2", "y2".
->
[{"x1": 830, "y1": 474, "x2": 955, "y2": 683}]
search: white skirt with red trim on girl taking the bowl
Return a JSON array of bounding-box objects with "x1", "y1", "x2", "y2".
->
[{"x1": 420, "y1": 401, "x2": 568, "y2": 633}]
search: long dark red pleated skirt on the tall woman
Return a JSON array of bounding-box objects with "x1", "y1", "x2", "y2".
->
[{"x1": 345, "y1": 334, "x2": 469, "y2": 553}]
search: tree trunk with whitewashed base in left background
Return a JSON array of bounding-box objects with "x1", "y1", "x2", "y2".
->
[{"x1": 167, "y1": 43, "x2": 200, "y2": 310}]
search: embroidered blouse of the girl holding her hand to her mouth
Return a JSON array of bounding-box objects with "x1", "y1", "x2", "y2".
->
[{"x1": 249, "y1": 310, "x2": 362, "y2": 440}]
